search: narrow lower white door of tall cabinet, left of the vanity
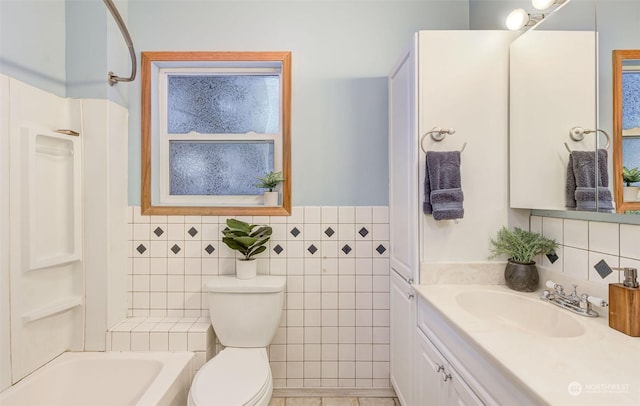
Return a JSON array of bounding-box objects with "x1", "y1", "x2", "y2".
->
[{"x1": 389, "y1": 271, "x2": 416, "y2": 406}]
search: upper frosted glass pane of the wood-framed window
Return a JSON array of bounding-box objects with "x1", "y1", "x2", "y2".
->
[{"x1": 167, "y1": 75, "x2": 280, "y2": 134}]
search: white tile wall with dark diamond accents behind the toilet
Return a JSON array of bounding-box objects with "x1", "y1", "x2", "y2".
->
[{"x1": 125, "y1": 206, "x2": 390, "y2": 388}]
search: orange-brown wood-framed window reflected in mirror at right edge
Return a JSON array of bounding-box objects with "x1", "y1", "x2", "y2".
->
[{"x1": 613, "y1": 50, "x2": 640, "y2": 213}]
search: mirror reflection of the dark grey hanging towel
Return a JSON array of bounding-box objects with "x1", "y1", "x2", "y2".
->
[{"x1": 566, "y1": 149, "x2": 613, "y2": 212}]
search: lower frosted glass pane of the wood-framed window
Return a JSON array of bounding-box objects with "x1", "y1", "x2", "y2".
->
[{"x1": 169, "y1": 141, "x2": 273, "y2": 196}]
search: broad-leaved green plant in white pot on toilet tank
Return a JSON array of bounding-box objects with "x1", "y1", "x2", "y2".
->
[{"x1": 222, "y1": 219, "x2": 273, "y2": 279}]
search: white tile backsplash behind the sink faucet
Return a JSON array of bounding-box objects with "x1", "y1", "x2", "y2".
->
[{"x1": 530, "y1": 216, "x2": 640, "y2": 284}]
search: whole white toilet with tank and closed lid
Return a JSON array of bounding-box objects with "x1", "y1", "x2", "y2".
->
[{"x1": 188, "y1": 275, "x2": 286, "y2": 406}]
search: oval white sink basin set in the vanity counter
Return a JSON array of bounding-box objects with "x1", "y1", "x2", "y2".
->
[{"x1": 456, "y1": 290, "x2": 585, "y2": 337}]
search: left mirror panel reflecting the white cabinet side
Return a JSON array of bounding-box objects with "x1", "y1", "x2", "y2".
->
[{"x1": 509, "y1": 1, "x2": 596, "y2": 211}]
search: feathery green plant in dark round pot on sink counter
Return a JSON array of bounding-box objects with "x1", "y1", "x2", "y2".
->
[{"x1": 489, "y1": 227, "x2": 558, "y2": 292}]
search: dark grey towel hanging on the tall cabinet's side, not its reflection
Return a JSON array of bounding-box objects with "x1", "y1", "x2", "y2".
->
[{"x1": 422, "y1": 151, "x2": 464, "y2": 220}]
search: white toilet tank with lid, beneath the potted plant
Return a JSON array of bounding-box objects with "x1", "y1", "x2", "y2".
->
[{"x1": 206, "y1": 275, "x2": 286, "y2": 348}]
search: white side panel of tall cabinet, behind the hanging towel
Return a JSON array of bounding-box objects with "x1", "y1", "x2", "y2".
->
[{"x1": 418, "y1": 31, "x2": 513, "y2": 262}]
